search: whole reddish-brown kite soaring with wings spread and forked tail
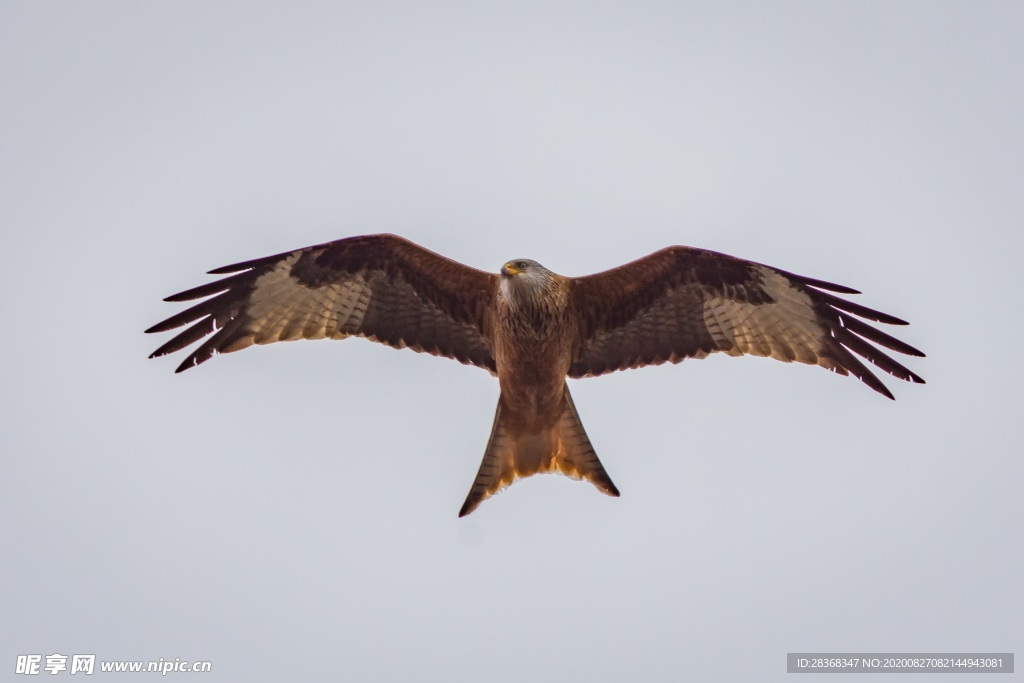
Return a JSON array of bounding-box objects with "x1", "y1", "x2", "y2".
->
[{"x1": 146, "y1": 234, "x2": 924, "y2": 517}]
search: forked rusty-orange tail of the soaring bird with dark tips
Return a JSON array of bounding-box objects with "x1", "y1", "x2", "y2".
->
[{"x1": 459, "y1": 387, "x2": 618, "y2": 517}]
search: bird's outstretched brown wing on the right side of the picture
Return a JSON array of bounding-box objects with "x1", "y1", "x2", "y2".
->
[{"x1": 569, "y1": 247, "x2": 924, "y2": 398}]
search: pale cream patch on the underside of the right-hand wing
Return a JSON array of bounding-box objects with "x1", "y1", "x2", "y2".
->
[{"x1": 703, "y1": 267, "x2": 821, "y2": 365}]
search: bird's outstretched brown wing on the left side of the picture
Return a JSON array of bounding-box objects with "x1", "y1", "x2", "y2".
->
[{"x1": 146, "y1": 234, "x2": 498, "y2": 373}]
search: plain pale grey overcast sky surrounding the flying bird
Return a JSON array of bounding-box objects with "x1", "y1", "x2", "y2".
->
[{"x1": 0, "y1": 1, "x2": 1024, "y2": 683}]
